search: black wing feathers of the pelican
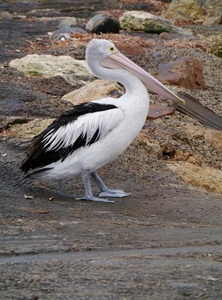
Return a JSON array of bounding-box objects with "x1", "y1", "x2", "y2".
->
[{"x1": 21, "y1": 102, "x2": 117, "y2": 173}]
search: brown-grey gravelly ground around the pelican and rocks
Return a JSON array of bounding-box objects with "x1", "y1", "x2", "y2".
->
[{"x1": 0, "y1": 1, "x2": 222, "y2": 299}]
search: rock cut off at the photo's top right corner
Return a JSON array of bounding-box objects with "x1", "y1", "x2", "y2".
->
[{"x1": 203, "y1": 0, "x2": 222, "y2": 25}]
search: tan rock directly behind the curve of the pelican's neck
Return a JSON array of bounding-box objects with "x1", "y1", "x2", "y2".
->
[{"x1": 62, "y1": 79, "x2": 122, "y2": 104}]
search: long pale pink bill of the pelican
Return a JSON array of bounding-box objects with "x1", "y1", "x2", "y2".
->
[{"x1": 102, "y1": 52, "x2": 185, "y2": 105}]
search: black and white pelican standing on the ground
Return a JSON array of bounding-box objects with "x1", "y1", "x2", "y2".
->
[{"x1": 21, "y1": 39, "x2": 185, "y2": 202}]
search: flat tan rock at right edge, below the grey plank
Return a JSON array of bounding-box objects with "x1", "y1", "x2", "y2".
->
[{"x1": 167, "y1": 162, "x2": 222, "y2": 194}]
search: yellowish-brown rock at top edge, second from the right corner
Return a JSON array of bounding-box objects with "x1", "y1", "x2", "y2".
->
[{"x1": 162, "y1": 0, "x2": 204, "y2": 23}]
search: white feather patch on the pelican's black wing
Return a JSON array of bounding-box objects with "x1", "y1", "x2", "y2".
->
[{"x1": 43, "y1": 108, "x2": 124, "y2": 151}]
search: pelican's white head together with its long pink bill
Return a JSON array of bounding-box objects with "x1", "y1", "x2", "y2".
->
[{"x1": 86, "y1": 39, "x2": 185, "y2": 104}]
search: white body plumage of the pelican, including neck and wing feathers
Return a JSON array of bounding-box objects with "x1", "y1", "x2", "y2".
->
[{"x1": 38, "y1": 74, "x2": 149, "y2": 179}]
